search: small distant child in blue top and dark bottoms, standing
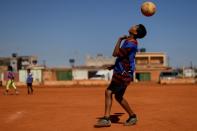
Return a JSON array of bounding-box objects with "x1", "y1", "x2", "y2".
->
[{"x1": 26, "y1": 69, "x2": 33, "y2": 94}]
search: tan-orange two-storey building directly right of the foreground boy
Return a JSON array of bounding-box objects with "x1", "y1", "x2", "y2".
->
[{"x1": 135, "y1": 52, "x2": 171, "y2": 81}]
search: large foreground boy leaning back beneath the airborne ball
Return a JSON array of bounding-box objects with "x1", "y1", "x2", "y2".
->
[{"x1": 95, "y1": 24, "x2": 146, "y2": 127}]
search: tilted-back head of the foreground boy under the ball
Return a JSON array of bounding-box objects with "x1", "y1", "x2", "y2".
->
[{"x1": 129, "y1": 24, "x2": 147, "y2": 39}]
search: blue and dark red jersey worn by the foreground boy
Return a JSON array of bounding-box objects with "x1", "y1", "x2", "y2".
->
[{"x1": 112, "y1": 40, "x2": 138, "y2": 83}]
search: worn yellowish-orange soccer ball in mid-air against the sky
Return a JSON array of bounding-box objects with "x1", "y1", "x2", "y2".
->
[{"x1": 141, "y1": 1, "x2": 156, "y2": 17}]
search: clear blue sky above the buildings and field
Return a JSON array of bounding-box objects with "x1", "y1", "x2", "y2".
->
[{"x1": 0, "y1": 0, "x2": 197, "y2": 67}]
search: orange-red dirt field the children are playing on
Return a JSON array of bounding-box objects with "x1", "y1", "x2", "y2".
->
[{"x1": 0, "y1": 83, "x2": 197, "y2": 131}]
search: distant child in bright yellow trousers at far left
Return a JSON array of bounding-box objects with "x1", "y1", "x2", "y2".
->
[{"x1": 5, "y1": 66, "x2": 18, "y2": 95}]
